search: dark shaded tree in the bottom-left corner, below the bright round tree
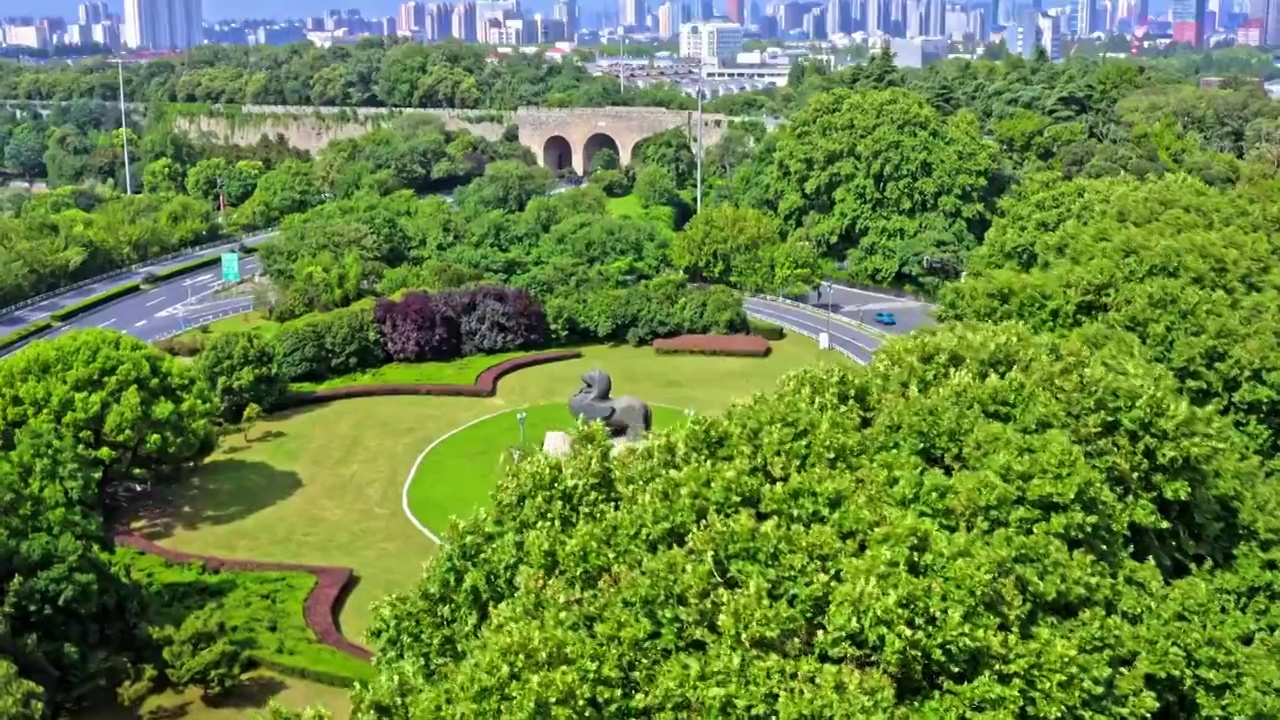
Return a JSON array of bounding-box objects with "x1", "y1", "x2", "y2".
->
[{"x1": 0, "y1": 420, "x2": 138, "y2": 719}]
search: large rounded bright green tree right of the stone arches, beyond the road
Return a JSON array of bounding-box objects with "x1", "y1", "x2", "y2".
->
[{"x1": 771, "y1": 88, "x2": 996, "y2": 282}]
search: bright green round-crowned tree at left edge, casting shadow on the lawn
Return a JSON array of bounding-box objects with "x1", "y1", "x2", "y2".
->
[{"x1": 0, "y1": 329, "x2": 216, "y2": 509}]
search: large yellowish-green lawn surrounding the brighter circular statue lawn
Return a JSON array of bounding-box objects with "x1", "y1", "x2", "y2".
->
[{"x1": 117, "y1": 337, "x2": 847, "y2": 712}]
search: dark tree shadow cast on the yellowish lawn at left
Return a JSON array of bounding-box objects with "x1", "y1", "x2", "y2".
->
[{"x1": 129, "y1": 457, "x2": 302, "y2": 542}]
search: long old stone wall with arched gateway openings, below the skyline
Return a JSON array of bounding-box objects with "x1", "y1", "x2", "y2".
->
[{"x1": 0, "y1": 100, "x2": 732, "y2": 167}]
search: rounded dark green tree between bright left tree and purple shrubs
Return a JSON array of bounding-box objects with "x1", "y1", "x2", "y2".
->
[{"x1": 196, "y1": 331, "x2": 288, "y2": 417}]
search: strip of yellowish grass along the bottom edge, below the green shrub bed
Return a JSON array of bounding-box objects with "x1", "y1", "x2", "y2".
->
[{"x1": 72, "y1": 671, "x2": 351, "y2": 720}]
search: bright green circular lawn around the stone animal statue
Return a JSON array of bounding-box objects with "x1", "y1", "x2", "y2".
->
[{"x1": 408, "y1": 401, "x2": 685, "y2": 534}]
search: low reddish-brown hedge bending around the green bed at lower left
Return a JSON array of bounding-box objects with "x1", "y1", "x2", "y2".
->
[{"x1": 115, "y1": 530, "x2": 372, "y2": 661}]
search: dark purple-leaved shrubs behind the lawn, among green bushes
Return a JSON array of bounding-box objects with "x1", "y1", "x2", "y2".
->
[{"x1": 374, "y1": 286, "x2": 548, "y2": 363}]
